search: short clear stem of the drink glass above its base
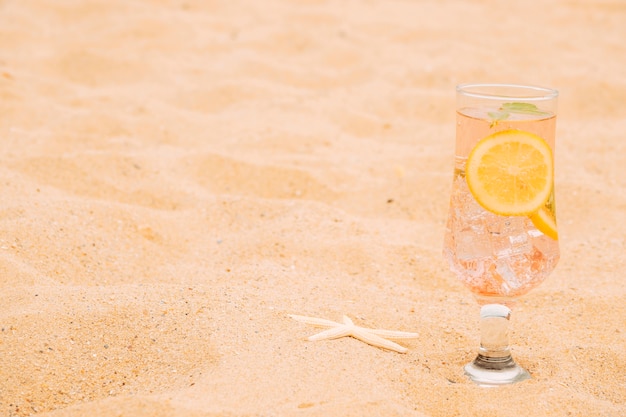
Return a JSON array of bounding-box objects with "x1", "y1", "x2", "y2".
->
[{"x1": 474, "y1": 304, "x2": 516, "y2": 370}]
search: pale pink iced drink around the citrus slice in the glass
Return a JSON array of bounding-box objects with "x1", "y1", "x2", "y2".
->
[{"x1": 444, "y1": 108, "x2": 559, "y2": 298}]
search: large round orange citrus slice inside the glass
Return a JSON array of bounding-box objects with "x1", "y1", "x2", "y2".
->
[{"x1": 465, "y1": 129, "x2": 554, "y2": 216}]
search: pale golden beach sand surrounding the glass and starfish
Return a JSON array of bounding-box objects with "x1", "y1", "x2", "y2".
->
[{"x1": 0, "y1": 0, "x2": 626, "y2": 417}]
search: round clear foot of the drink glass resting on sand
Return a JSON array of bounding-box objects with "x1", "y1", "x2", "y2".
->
[{"x1": 464, "y1": 355, "x2": 530, "y2": 387}]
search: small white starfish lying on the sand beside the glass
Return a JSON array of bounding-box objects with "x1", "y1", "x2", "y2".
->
[{"x1": 289, "y1": 314, "x2": 418, "y2": 353}]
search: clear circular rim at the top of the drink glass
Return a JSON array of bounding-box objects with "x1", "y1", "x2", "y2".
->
[{"x1": 456, "y1": 83, "x2": 559, "y2": 101}]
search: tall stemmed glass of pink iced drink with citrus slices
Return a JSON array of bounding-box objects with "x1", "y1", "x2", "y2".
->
[{"x1": 444, "y1": 84, "x2": 559, "y2": 386}]
